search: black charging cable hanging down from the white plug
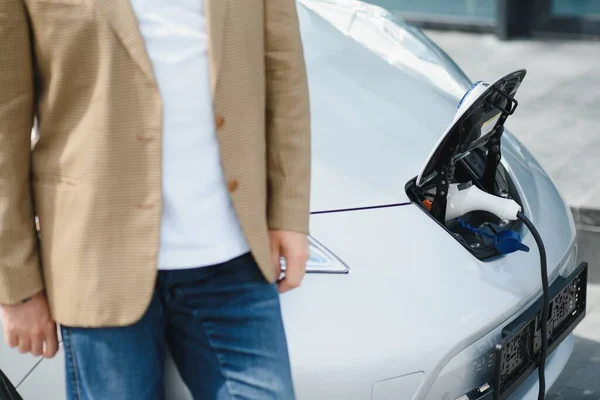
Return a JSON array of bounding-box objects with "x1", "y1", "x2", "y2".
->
[{"x1": 517, "y1": 212, "x2": 550, "y2": 400}]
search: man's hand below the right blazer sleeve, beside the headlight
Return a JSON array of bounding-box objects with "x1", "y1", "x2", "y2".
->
[{"x1": 269, "y1": 230, "x2": 308, "y2": 293}]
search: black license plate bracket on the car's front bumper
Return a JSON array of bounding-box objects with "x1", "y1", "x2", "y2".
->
[{"x1": 494, "y1": 263, "x2": 588, "y2": 400}]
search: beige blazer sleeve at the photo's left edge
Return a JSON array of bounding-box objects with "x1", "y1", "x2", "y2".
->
[{"x1": 0, "y1": 0, "x2": 43, "y2": 305}]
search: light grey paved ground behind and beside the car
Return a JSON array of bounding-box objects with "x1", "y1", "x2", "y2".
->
[{"x1": 426, "y1": 31, "x2": 600, "y2": 400}]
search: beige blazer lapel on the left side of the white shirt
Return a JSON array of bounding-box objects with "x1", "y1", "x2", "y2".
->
[{"x1": 96, "y1": 0, "x2": 155, "y2": 83}]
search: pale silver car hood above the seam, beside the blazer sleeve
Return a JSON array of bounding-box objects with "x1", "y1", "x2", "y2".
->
[{"x1": 299, "y1": 6, "x2": 472, "y2": 211}]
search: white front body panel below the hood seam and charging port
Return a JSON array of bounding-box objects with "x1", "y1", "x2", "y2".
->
[{"x1": 282, "y1": 200, "x2": 572, "y2": 399}]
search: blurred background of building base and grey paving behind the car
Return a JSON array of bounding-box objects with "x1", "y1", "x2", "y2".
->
[{"x1": 360, "y1": 0, "x2": 600, "y2": 400}]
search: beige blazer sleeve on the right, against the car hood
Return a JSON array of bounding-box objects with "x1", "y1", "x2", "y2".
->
[{"x1": 264, "y1": 0, "x2": 311, "y2": 233}]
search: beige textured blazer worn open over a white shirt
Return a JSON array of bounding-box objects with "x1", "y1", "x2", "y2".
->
[{"x1": 0, "y1": 0, "x2": 310, "y2": 327}]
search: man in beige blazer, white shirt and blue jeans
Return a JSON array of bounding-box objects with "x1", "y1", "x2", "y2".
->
[{"x1": 0, "y1": 0, "x2": 310, "y2": 400}]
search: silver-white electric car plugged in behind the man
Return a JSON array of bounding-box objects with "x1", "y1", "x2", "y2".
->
[{"x1": 0, "y1": 0, "x2": 587, "y2": 400}]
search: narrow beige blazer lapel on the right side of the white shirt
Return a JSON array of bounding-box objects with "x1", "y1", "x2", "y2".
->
[{"x1": 204, "y1": 0, "x2": 227, "y2": 97}]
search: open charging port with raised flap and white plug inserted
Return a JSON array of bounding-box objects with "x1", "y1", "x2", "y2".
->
[{"x1": 406, "y1": 70, "x2": 529, "y2": 260}]
